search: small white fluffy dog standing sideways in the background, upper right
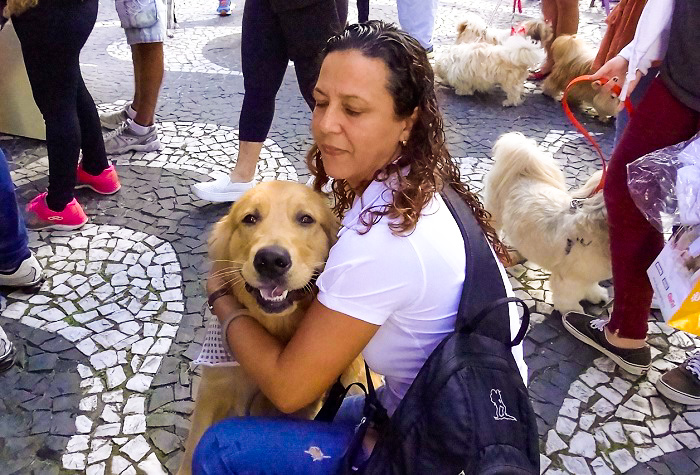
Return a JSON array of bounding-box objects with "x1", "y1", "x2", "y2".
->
[{"x1": 435, "y1": 35, "x2": 542, "y2": 106}]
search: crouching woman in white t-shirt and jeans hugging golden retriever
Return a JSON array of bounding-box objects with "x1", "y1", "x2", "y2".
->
[{"x1": 194, "y1": 21, "x2": 525, "y2": 473}]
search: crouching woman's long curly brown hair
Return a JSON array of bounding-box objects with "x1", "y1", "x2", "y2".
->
[{"x1": 306, "y1": 20, "x2": 509, "y2": 262}]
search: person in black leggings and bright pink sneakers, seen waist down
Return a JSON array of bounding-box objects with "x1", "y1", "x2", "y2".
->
[{"x1": 4, "y1": 0, "x2": 121, "y2": 230}]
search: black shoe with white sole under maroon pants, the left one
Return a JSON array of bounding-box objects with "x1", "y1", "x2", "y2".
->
[{"x1": 562, "y1": 312, "x2": 651, "y2": 374}]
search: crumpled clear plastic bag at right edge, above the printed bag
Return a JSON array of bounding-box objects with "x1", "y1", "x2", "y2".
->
[{"x1": 627, "y1": 134, "x2": 700, "y2": 232}]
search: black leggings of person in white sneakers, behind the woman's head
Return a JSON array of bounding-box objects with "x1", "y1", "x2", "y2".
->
[{"x1": 239, "y1": 0, "x2": 347, "y2": 142}]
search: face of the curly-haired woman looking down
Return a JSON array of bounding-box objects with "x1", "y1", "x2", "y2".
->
[{"x1": 311, "y1": 50, "x2": 417, "y2": 190}]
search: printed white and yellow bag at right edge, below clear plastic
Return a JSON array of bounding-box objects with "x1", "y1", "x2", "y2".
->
[{"x1": 647, "y1": 226, "x2": 700, "y2": 335}]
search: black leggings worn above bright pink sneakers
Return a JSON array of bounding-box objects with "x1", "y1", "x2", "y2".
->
[{"x1": 12, "y1": 0, "x2": 109, "y2": 211}]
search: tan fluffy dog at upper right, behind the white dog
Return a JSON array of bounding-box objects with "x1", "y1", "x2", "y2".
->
[{"x1": 542, "y1": 35, "x2": 620, "y2": 122}]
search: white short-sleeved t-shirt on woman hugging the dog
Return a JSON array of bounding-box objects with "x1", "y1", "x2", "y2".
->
[{"x1": 317, "y1": 177, "x2": 527, "y2": 414}]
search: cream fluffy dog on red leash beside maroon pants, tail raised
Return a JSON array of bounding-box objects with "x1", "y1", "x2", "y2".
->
[{"x1": 484, "y1": 132, "x2": 612, "y2": 314}]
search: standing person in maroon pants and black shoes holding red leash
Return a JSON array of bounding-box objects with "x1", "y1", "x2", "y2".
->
[{"x1": 564, "y1": 0, "x2": 700, "y2": 404}]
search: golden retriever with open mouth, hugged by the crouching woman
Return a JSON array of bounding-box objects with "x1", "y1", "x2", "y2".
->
[{"x1": 178, "y1": 181, "x2": 364, "y2": 475}]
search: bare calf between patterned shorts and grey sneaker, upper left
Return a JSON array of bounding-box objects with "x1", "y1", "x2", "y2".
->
[{"x1": 131, "y1": 43, "x2": 165, "y2": 126}]
